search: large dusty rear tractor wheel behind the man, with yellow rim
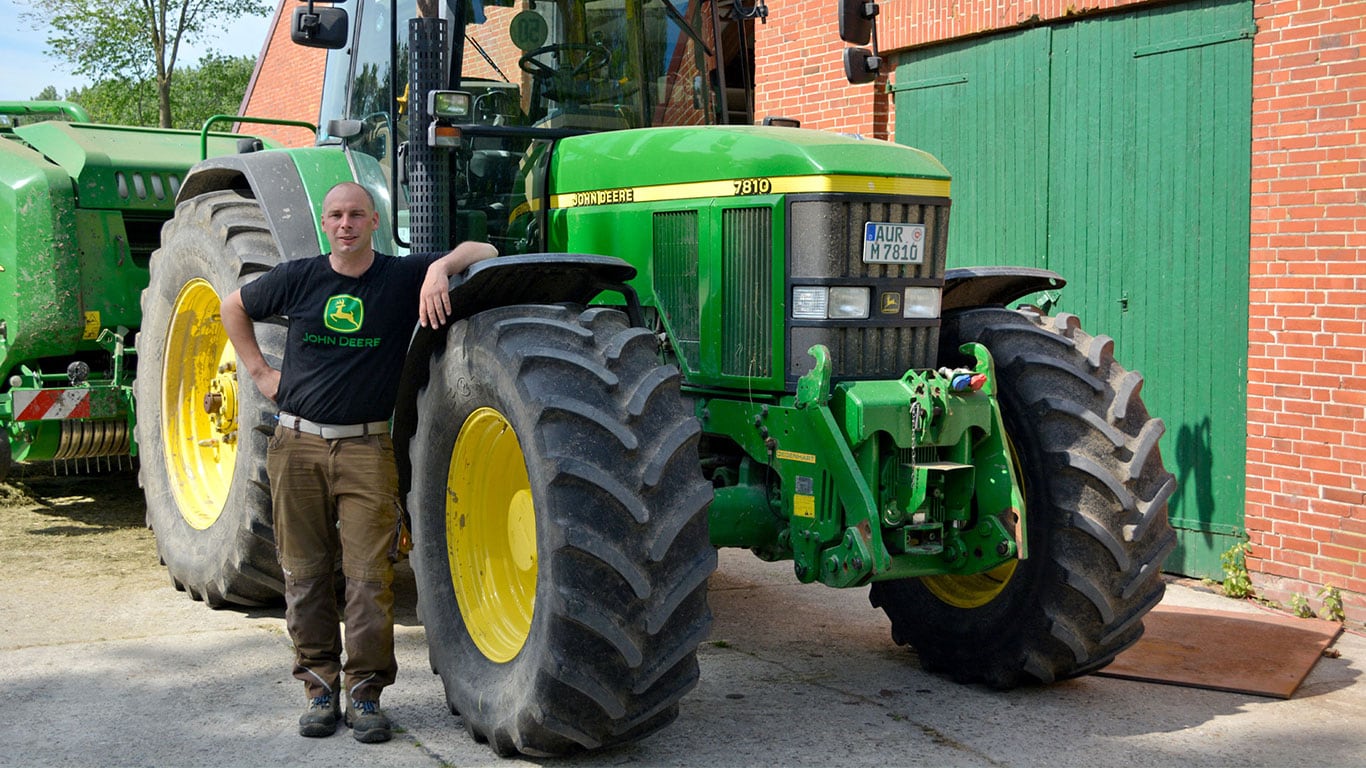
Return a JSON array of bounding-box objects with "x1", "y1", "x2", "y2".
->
[{"x1": 134, "y1": 190, "x2": 284, "y2": 608}]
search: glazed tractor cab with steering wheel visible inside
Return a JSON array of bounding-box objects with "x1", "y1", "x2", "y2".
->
[{"x1": 294, "y1": 0, "x2": 754, "y2": 253}]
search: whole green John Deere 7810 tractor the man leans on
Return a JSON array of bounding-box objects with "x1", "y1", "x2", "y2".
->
[{"x1": 137, "y1": 0, "x2": 1173, "y2": 756}]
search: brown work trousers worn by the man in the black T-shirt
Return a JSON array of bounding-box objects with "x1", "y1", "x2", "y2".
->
[{"x1": 266, "y1": 426, "x2": 403, "y2": 701}]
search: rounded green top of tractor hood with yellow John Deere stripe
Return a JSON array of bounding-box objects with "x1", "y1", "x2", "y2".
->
[{"x1": 550, "y1": 126, "x2": 949, "y2": 195}]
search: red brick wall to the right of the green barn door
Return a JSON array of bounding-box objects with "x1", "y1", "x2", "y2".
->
[{"x1": 1247, "y1": 0, "x2": 1366, "y2": 618}]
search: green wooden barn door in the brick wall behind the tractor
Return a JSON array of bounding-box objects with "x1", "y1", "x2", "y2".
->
[{"x1": 893, "y1": 0, "x2": 1254, "y2": 577}]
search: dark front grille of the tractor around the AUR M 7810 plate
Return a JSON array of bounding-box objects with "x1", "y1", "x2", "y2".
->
[{"x1": 787, "y1": 195, "x2": 948, "y2": 383}]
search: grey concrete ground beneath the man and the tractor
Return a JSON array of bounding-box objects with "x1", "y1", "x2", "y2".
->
[{"x1": 0, "y1": 467, "x2": 1366, "y2": 768}]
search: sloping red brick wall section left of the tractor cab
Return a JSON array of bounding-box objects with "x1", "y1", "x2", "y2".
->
[{"x1": 238, "y1": 0, "x2": 326, "y2": 146}]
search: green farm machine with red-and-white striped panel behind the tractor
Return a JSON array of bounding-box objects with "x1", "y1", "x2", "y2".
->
[{"x1": 0, "y1": 101, "x2": 282, "y2": 480}]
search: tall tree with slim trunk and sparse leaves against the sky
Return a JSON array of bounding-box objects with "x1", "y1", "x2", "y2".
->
[{"x1": 25, "y1": 0, "x2": 269, "y2": 128}]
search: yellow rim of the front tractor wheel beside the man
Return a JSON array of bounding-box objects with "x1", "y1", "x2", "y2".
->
[{"x1": 445, "y1": 409, "x2": 537, "y2": 664}]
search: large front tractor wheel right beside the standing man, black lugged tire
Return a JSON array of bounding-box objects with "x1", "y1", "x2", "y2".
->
[{"x1": 410, "y1": 306, "x2": 716, "y2": 756}]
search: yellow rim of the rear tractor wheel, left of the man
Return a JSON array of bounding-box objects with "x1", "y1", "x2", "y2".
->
[{"x1": 161, "y1": 277, "x2": 238, "y2": 530}]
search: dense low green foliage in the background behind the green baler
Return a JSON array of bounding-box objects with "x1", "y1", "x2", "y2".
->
[{"x1": 67, "y1": 53, "x2": 255, "y2": 130}]
